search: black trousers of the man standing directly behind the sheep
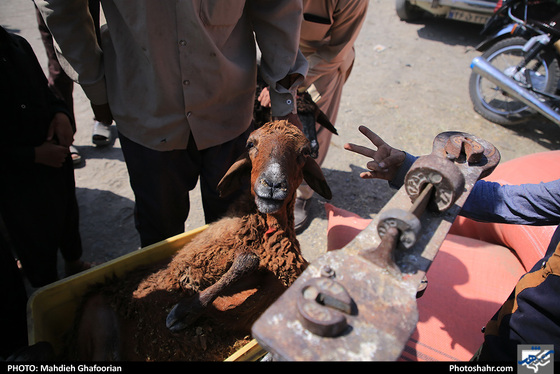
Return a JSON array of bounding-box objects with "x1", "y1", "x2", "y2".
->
[{"x1": 119, "y1": 125, "x2": 253, "y2": 247}]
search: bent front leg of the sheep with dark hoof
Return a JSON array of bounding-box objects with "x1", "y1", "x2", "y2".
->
[{"x1": 165, "y1": 252, "x2": 260, "y2": 332}]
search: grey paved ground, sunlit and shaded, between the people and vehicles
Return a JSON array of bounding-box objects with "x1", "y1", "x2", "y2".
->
[{"x1": 0, "y1": 0, "x2": 560, "y2": 272}]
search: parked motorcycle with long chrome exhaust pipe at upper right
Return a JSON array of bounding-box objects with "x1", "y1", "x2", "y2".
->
[{"x1": 469, "y1": 0, "x2": 560, "y2": 125}]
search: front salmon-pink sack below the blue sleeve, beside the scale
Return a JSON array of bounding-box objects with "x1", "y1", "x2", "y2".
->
[{"x1": 401, "y1": 235, "x2": 525, "y2": 361}]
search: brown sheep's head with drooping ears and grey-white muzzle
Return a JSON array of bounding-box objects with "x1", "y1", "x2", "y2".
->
[{"x1": 218, "y1": 121, "x2": 332, "y2": 219}]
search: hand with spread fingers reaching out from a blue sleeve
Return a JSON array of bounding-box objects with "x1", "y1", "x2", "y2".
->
[{"x1": 344, "y1": 126, "x2": 406, "y2": 181}]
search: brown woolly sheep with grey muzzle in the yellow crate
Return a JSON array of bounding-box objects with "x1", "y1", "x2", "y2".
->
[{"x1": 69, "y1": 121, "x2": 331, "y2": 361}]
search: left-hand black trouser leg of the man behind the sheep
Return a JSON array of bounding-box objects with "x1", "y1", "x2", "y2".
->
[{"x1": 119, "y1": 134, "x2": 200, "y2": 247}]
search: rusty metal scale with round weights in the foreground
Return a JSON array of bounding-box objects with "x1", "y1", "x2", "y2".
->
[{"x1": 252, "y1": 132, "x2": 500, "y2": 361}]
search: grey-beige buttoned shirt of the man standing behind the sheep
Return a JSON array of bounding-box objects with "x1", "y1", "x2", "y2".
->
[{"x1": 36, "y1": 0, "x2": 307, "y2": 151}]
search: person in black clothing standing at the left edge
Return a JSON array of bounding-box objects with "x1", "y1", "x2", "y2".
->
[{"x1": 0, "y1": 27, "x2": 87, "y2": 356}]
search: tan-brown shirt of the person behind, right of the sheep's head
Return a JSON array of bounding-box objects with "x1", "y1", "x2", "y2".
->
[{"x1": 300, "y1": 0, "x2": 369, "y2": 87}]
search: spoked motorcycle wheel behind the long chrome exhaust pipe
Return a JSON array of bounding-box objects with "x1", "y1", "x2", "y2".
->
[{"x1": 469, "y1": 37, "x2": 560, "y2": 125}]
